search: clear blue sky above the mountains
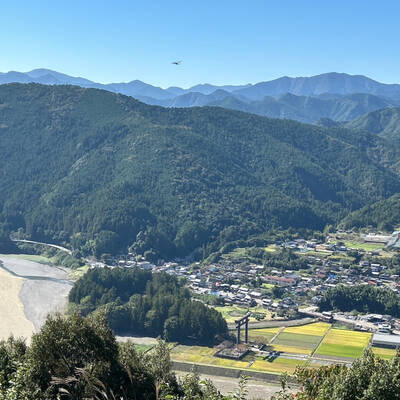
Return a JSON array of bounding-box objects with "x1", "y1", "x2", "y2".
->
[{"x1": 0, "y1": 0, "x2": 400, "y2": 87}]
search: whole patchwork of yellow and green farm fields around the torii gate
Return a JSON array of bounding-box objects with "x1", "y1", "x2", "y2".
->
[{"x1": 171, "y1": 322, "x2": 376, "y2": 373}]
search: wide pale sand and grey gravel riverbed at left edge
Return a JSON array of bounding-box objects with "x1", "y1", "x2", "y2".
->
[{"x1": 0, "y1": 255, "x2": 73, "y2": 342}]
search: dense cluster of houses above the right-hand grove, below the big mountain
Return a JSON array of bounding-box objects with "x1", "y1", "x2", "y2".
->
[{"x1": 94, "y1": 232, "x2": 400, "y2": 324}]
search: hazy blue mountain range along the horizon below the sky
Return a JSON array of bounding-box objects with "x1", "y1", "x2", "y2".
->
[{"x1": 0, "y1": 69, "x2": 400, "y2": 123}]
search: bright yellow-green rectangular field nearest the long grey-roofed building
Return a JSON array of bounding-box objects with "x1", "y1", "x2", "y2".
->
[{"x1": 316, "y1": 329, "x2": 372, "y2": 358}]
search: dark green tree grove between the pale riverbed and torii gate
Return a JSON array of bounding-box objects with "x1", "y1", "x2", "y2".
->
[{"x1": 69, "y1": 268, "x2": 228, "y2": 345}]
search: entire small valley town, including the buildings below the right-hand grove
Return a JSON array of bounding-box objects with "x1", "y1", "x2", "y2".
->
[{"x1": 91, "y1": 231, "x2": 400, "y2": 333}]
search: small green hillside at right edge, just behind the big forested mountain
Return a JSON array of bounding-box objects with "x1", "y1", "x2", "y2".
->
[{"x1": 345, "y1": 108, "x2": 400, "y2": 143}]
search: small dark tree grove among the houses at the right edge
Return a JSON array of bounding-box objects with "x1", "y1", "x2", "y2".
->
[{"x1": 319, "y1": 285, "x2": 400, "y2": 317}]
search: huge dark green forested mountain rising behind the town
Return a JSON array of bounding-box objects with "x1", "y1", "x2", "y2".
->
[{"x1": 0, "y1": 84, "x2": 400, "y2": 257}]
